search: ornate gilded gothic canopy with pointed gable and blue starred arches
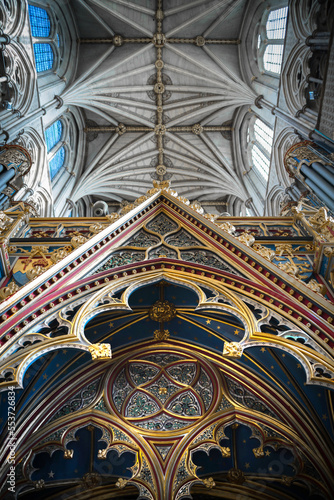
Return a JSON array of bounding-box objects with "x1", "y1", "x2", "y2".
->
[{"x1": 0, "y1": 183, "x2": 334, "y2": 500}]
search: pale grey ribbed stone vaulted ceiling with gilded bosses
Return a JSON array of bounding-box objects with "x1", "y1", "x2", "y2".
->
[{"x1": 67, "y1": 0, "x2": 256, "y2": 211}]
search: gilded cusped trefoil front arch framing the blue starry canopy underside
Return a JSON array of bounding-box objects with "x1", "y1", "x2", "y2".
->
[{"x1": 0, "y1": 266, "x2": 334, "y2": 396}]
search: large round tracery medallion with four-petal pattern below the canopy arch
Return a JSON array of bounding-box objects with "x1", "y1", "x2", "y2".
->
[{"x1": 108, "y1": 350, "x2": 219, "y2": 433}]
